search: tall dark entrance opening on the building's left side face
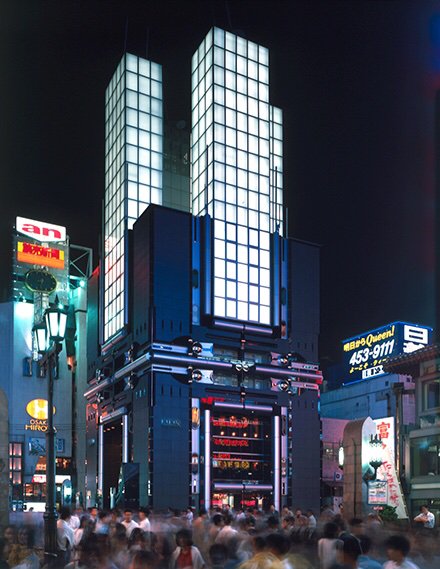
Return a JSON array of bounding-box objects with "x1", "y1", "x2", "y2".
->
[{"x1": 102, "y1": 420, "x2": 122, "y2": 508}]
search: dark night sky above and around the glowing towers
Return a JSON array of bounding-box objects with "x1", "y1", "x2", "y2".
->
[{"x1": 0, "y1": 0, "x2": 440, "y2": 365}]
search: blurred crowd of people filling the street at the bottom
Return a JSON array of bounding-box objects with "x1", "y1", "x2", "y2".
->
[{"x1": 0, "y1": 506, "x2": 440, "y2": 569}]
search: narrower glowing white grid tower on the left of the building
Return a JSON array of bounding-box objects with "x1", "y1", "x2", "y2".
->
[{"x1": 104, "y1": 54, "x2": 163, "y2": 342}]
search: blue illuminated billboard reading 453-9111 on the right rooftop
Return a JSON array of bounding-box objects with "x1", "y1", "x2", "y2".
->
[{"x1": 342, "y1": 322, "x2": 432, "y2": 381}]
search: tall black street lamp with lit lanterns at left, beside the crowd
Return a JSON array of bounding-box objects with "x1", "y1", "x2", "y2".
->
[{"x1": 34, "y1": 298, "x2": 67, "y2": 565}]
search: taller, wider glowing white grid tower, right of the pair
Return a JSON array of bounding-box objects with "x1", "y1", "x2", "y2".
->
[{"x1": 191, "y1": 28, "x2": 283, "y2": 325}]
